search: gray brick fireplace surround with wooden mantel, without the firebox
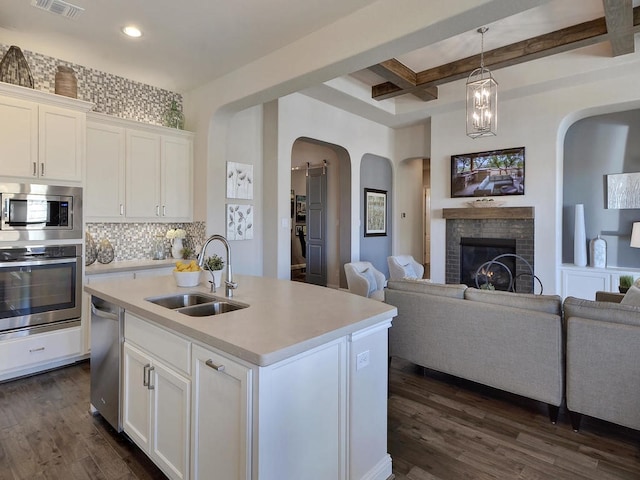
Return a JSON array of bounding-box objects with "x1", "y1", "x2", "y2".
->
[{"x1": 442, "y1": 207, "x2": 540, "y2": 293}]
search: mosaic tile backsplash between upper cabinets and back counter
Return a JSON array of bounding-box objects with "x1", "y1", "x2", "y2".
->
[{"x1": 86, "y1": 222, "x2": 206, "y2": 262}]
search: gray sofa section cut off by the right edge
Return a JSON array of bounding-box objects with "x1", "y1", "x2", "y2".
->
[{"x1": 564, "y1": 294, "x2": 640, "y2": 431}]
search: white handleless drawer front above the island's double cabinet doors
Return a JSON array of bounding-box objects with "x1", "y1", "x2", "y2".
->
[{"x1": 124, "y1": 312, "x2": 191, "y2": 375}]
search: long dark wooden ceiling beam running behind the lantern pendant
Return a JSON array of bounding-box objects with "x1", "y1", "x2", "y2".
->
[{"x1": 371, "y1": 5, "x2": 640, "y2": 100}]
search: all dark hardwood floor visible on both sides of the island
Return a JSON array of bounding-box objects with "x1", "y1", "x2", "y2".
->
[{"x1": 0, "y1": 359, "x2": 640, "y2": 480}]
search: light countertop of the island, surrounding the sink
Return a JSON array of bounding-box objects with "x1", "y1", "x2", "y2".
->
[{"x1": 84, "y1": 275, "x2": 397, "y2": 366}]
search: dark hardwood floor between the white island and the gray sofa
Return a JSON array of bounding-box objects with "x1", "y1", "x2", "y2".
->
[{"x1": 388, "y1": 359, "x2": 640, "y2": 480}]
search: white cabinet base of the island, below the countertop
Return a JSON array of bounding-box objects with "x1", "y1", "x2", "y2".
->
[{"x1": 123, "y1": 312, "x2": 392, "y2": 480}]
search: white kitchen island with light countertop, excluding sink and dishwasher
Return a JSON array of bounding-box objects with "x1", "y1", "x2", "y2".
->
[{"x1": 85, "y1": 272, "x2": 397, "y2": 480}]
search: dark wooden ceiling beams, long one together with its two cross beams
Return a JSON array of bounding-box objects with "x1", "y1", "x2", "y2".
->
[{"x1": 369, "y1": 0, "x2": 640, "y2": 101}]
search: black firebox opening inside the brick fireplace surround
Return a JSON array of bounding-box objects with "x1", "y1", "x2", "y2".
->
[{"x1": 460, "y1": 237, "x2": 516, "y2": 291}]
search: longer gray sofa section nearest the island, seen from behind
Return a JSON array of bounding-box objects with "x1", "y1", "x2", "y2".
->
[{"x1": 385, "y1": 280, "x2": 564, "y2": 423}]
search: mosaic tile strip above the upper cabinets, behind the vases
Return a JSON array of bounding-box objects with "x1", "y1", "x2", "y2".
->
[{"x1": 0, "y1": 44, "x2": 182, "y2": 125}]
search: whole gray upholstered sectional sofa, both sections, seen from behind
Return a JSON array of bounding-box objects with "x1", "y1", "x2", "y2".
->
[{"x1": 385, "y1": 279, "x2": 640, "y2": 431}]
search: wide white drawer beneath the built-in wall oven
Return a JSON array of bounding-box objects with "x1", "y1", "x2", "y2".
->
[{"x1": 0, "y1": 327, "x2": 81, "y2": 373}]
